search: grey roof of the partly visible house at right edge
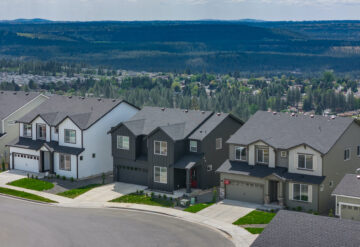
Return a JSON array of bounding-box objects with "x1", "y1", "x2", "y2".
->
[{"x1": 332, "y1": 174, "x2": 360, "y2": 198}]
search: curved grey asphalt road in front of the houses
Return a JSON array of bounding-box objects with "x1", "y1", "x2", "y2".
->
[{"x1": 0, "y1": 196, "x2": 234, "y2": 247}]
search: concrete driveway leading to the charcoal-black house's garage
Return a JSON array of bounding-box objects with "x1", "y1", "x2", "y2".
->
[{"x1": 74, "y1": 182, "x2": 147, "y2": 203}]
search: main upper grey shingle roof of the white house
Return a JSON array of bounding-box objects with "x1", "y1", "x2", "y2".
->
[{"x1": 19, "y1": 95, "x2": 135, "y2": 130}]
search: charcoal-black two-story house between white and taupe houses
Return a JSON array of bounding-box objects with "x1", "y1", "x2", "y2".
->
[{"x1": 110, "y1": 107, "x2": 242, "y2": 192}]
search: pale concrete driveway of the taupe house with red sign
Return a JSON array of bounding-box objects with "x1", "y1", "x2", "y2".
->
[{"x1": 197, "y1": 200, "x2": 259, "y2": 224}]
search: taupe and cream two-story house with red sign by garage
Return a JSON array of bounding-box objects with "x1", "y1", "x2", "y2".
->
[{"x1": 218, "y1": 111, "x2": 360, "y2": 213}]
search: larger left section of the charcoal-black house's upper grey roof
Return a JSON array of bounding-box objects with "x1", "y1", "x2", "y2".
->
[{"x1": 112, "y1": 106, "x2": 213, "y2": 141}]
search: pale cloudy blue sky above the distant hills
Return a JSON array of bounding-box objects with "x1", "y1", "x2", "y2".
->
[{"x1": 0, "y1": 0, "x2": 360, "y2": 21}]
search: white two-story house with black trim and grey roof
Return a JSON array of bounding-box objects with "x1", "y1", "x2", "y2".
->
[{"x1": 9, "y1": 95, "x2": 138, "y2": 179}]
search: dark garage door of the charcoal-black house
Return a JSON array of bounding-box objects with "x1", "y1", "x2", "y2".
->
[{"x1": 117, "y1": 166, "x2": 148, "y2": 185}]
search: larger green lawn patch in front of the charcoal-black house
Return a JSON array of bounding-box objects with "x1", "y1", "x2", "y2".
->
[{"x1": 110, "y1": 193, "x2": 174, "y2": 207}]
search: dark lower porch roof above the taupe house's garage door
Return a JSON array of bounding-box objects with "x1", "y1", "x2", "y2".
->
[{"x1": 216, "y1": 160, "x2": 325, "y2": 184}]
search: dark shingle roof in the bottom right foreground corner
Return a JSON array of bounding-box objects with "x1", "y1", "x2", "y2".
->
[{"x1": 251, "y1": 210, "x2": 360, "y2": 247}]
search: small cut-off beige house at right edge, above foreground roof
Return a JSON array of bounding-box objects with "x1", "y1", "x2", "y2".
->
[{"x1": 332, "y1": 173, "x2": 360, "y2": 221}]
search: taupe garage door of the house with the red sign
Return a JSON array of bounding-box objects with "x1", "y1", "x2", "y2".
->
[{"x1": 225, "y1": 181, "x2": 264, "y2": 204}]
